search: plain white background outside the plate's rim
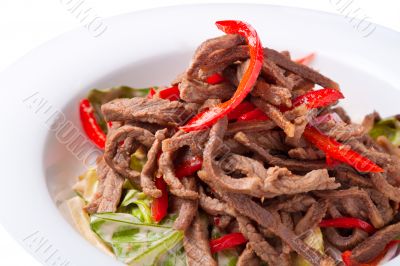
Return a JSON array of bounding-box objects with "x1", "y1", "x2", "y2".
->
[{"x1": 0, "y1": 0, "x2": 400, "y2": 266}]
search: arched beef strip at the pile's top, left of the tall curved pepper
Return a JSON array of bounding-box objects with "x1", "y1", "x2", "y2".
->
[{"x1": 186, "y1": 34, "x2": 245, "y2": 79}]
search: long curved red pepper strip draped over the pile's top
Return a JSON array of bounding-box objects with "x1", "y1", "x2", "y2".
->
[{"x1": 181, "y1": 20, "x2": 264, "y2": 132}]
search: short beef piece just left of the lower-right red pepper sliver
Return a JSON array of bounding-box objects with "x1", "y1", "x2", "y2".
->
[{"x1": 294, "y1": 201, "x2": 328, "y2": 235}]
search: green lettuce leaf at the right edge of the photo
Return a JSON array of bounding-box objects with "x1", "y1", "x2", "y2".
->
[{"x1": 369, "y1": 117, "x2": 400, "y2": 146}]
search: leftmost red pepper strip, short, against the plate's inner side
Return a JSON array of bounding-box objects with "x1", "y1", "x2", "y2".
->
[{"x1": 79, "y1": 99, "x2": 106, "y2": 149}]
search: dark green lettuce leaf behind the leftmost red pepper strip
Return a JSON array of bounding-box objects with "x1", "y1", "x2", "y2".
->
[{"x1": 87, "y1": 86, "x2": 150, "y2": 132}]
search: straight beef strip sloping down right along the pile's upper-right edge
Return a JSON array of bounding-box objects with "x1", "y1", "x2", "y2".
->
[{"x1": 264, "y1": 48, "x2": 339, "y2": 89}]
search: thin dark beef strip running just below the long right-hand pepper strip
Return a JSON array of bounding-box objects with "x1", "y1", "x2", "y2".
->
[{"x1": 235, "y1": 132, "x2": 329, "y2": 172}]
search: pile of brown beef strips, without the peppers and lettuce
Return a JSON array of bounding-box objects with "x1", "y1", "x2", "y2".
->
[{"x1": 86, "y1": 35, "x2": 400, "y2": 266}]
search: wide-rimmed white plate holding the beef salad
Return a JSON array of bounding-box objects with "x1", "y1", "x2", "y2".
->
[{"x1": 0, "y1": 5, "x2": 400, "y2": 266}]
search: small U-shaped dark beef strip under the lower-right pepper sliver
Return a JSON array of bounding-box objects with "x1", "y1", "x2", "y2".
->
[{"x1": 322, "y1": 228, "x2": 368, "y2": 251}]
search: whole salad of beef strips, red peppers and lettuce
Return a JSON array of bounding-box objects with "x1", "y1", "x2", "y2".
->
[{"x1": 67, "y1": 20, "x2": 400, "y2": 266}]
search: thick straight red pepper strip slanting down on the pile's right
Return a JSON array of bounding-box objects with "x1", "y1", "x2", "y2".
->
[{"x1": 303, "y1": 126, "x2": 384, "y2": 173}]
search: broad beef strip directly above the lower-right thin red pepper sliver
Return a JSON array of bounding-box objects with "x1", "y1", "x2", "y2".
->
[{"x1": 314, "y1": 187, "x2": 384, "y2": 228}]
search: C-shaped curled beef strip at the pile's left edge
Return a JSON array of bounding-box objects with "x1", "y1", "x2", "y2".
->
[{"x1": 104, "y1": 125, "x2": 155, "y2": 185}]
